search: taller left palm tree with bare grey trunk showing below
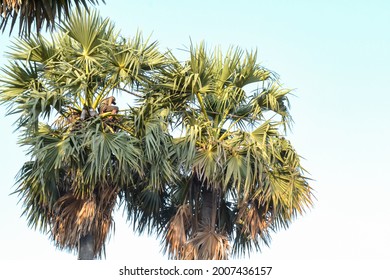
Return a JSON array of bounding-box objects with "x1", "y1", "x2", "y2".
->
[{"x1": 0, "y1": 8, "x2": 173, "y2": 259}]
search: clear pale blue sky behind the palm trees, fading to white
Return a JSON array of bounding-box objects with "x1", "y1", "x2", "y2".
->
[{"x1": 0, "y1": 0, "x2": 390, "y2": 260}]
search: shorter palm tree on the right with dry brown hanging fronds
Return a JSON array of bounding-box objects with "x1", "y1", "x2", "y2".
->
[{"x1": 146, "y1": 43, "x2": 312, "y2": 259}]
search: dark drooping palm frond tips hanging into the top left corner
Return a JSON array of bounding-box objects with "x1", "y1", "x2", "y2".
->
[{"x1": 0, "y1": 0, "x2": 105, "y2": 35}]
